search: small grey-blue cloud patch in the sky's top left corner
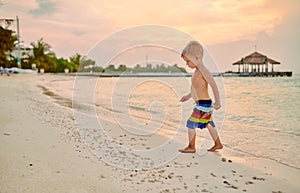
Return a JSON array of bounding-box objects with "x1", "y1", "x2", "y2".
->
[{"x1": 29, "y1": 0, "x2": 56, "y2": 16}]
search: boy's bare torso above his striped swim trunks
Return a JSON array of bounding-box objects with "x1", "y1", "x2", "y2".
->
[{"x1": 191, "y1": 69, "x2": 210, "y2": 101}]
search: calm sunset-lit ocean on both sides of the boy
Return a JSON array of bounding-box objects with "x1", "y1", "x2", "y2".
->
[{"x1": 47, "y1": 74, "x2": 300, "y2": 169}]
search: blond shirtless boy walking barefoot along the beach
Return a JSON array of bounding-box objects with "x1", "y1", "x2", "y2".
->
[{"x1": 179, "y1": 41, "x2": 223, "y2": 153}]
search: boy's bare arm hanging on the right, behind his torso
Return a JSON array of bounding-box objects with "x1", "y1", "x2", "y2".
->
[{"x1": 197, "y1": 64, "x2": 221, "y2": 110}]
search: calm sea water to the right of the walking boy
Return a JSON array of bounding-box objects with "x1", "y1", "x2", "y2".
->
[{"x1": 222, "y1": 74, "x2": 300, "y2": 168}]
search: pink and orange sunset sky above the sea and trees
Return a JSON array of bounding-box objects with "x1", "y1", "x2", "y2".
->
[{"x1": 0, "y1": 0, "x2": 300, "y2": 73}]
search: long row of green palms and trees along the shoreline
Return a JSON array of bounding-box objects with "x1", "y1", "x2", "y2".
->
[{"x1": 0, "y1": 22, "x2": 186, "y2": 73}]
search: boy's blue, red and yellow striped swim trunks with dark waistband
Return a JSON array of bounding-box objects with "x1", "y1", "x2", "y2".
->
[{"x1": 186, "y1": 100, "x2": 215, "y2": 129}]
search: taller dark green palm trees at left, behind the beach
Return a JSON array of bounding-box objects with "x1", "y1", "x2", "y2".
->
[{"x1": 0, "y1": 26, "x2": 93, "y2": 73}]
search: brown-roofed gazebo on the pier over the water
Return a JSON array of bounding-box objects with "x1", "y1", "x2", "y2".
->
[{"x1": 232, "y1": 51, "x2": 280, "y2": 74}]
